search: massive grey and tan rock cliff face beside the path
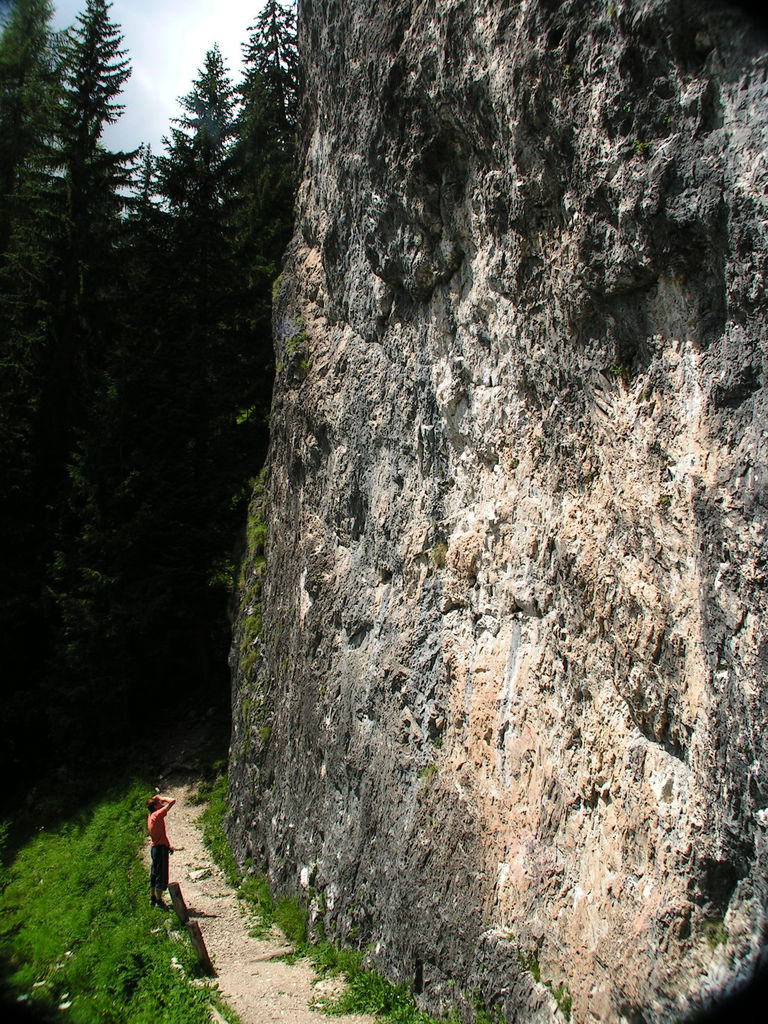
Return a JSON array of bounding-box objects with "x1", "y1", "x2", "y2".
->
[{"x1": 230, "y1": 0, "x2": 768, "y2": 1022}]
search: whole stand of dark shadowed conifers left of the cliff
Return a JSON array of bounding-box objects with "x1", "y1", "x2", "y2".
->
[{"x1": 0, "y1": 0, "x2": 298, "y2": 798}]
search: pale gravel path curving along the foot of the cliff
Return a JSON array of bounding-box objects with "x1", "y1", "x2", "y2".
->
[{"x1": 144, "y1": 775, "x2": 374, "y2": 1024}]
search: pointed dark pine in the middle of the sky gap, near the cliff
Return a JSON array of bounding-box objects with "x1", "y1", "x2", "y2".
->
[{"x1": 144, "y1": 46, "x2": 250, "y2": 682}]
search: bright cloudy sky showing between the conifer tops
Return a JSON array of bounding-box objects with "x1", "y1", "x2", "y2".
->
[{"x1": 53, "y1": 0, "x2": 262, "y2": 154}]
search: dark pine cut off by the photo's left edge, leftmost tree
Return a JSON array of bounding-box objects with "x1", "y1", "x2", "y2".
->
[{"x1": 0, "y1": 0, "x2": 60, "y2": 777}]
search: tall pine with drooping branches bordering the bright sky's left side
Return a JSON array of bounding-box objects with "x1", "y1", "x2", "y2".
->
[{"x1": 0, "y1": 0, "x2": 131, "y2": 485}]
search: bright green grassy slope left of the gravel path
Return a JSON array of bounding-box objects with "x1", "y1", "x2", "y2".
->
[{"x1": 0, "y1": 782, "x2": 227, "y2": 1024}]
